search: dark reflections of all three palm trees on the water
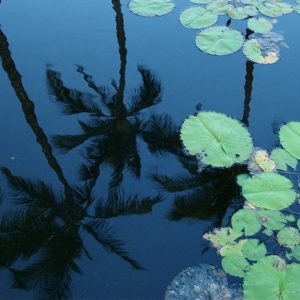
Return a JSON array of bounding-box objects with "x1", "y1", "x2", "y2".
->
[{"x1": 0, "y1": 0, "x2": 254, "y2": 299}]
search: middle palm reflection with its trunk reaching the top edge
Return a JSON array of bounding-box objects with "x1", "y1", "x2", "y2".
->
[{"x1": 47, "y1": 0, "x2": 161, "y2": 188}]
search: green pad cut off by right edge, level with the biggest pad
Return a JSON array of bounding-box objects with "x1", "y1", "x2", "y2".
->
[{"x1": 279, "y1": 122, "x2": 300, "y2": 159}]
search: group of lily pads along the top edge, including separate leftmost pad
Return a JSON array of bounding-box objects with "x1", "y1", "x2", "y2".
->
[{"x1": 129, "y1": 0, "x2": 300, "y2": 64}]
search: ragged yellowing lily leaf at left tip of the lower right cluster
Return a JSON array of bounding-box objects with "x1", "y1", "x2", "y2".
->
[{"x1": 203, "y1": 227, "x2": 243, "y2": 248}]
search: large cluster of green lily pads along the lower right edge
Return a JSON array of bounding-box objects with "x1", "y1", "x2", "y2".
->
[{"x1": 181, "y1": 112, "x2": 300, "y2": 300}]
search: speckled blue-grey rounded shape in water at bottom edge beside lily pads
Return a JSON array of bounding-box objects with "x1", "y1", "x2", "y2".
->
[{"x1": 165, "y1": 264, "x2": 243, "y2": 300}]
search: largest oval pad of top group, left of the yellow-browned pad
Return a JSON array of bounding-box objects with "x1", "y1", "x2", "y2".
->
[{"x1": 196, "y1": 26, "x2": 244, "y2": 55}]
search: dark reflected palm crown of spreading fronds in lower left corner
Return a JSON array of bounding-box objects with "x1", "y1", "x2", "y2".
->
[{"x1": 0, "y1": 168, "x2": 160, "y2": 299}]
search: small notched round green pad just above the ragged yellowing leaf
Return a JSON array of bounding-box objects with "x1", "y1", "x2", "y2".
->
[{"x1": 231, "y1": 209, "x2": 261, "y2": 236}]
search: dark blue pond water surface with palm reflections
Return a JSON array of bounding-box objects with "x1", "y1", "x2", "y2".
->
[{"x1": 0, "y1": 0, "x2": 300, "y2": 299}]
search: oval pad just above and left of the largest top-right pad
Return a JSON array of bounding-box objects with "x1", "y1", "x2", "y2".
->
[{"x1": 179, "y1": 6, "x2": 218, "y2": 29}]
